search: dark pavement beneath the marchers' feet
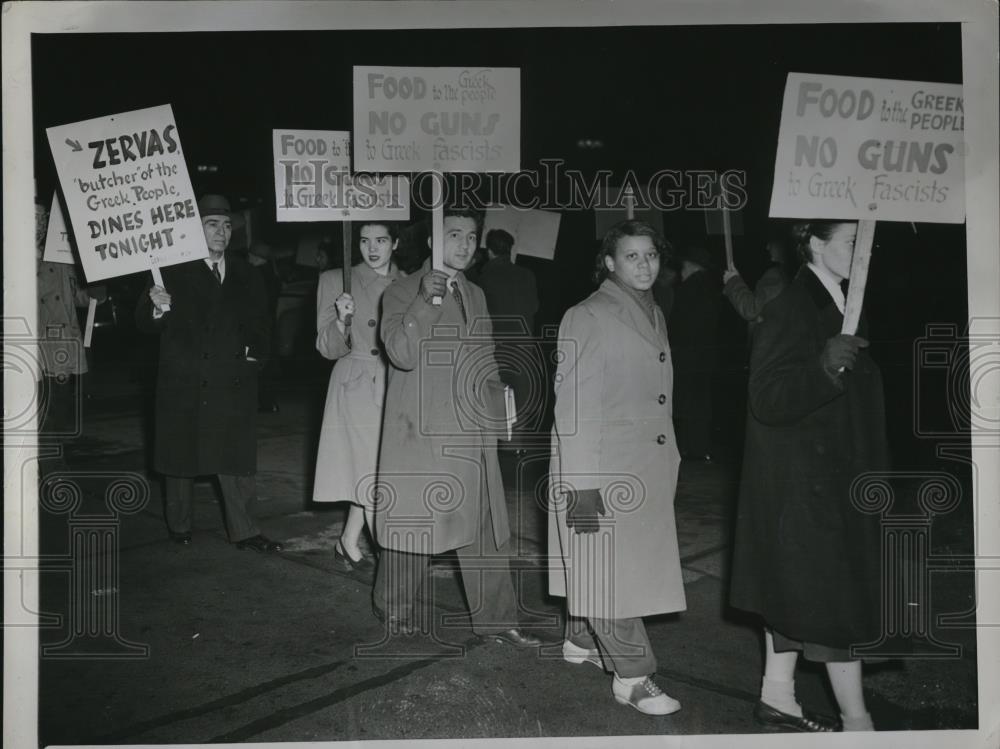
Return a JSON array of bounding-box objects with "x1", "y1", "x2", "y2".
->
[{"x1": 31, "y1": 356, "x2": 977, "y2": 744}]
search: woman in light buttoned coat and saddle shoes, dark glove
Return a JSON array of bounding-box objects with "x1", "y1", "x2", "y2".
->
[{"x1": 549, "y1": 221, "x2": 686, "y2": 715}]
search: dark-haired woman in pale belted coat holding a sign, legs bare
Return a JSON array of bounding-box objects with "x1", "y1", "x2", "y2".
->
[{"x1": 313, "y1": 222, "x2": 400, "y2": 578}]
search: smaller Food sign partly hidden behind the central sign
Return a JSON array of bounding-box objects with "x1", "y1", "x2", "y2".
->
[{"x1": 273, "y1": 130, "x2": 410, "y2": 221}]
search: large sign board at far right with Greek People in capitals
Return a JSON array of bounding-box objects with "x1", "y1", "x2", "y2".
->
[{"x1": 770, "y1": 73, "x2": 965, "y2": 223}]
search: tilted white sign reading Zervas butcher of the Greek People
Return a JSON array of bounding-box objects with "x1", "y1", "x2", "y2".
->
[{"x1": 46, "y1": 104, "x2": 208, "y2": 283}]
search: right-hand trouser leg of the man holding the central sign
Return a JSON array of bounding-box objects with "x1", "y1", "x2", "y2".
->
[{"x1": 455, "y1": 485, "x2": 518, "y2": 635}]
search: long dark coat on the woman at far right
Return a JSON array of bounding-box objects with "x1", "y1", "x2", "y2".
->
[{"x1": 730, "y1": 268, "x2": 888, "y2": 648}]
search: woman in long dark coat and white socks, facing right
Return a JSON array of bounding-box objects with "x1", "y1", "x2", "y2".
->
[{"x1": 730, "y1": 221, "x2": 888, "y2": 731}]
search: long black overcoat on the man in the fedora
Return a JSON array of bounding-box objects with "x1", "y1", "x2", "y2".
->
[{"x1": 136, "y1": 255, "x2": 270, "y2": 476}]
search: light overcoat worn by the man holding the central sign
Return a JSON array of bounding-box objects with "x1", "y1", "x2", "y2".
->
[{"x1": 372, "y1": 260, "x2": 510, "y2": 554}]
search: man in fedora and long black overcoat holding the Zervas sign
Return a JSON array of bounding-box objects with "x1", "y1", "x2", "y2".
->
[{"x1": 136, "y1": 195, "x2": 282, "y2": 552}]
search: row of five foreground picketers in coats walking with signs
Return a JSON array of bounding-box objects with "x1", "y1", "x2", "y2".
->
[{"x1": 137, "y1": 196, "x2": 886, "y2": 731}]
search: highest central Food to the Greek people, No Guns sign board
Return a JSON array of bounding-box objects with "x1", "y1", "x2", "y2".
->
[{"x1": 354, "y1": 66, "x2": 521, "y2": 172}]
